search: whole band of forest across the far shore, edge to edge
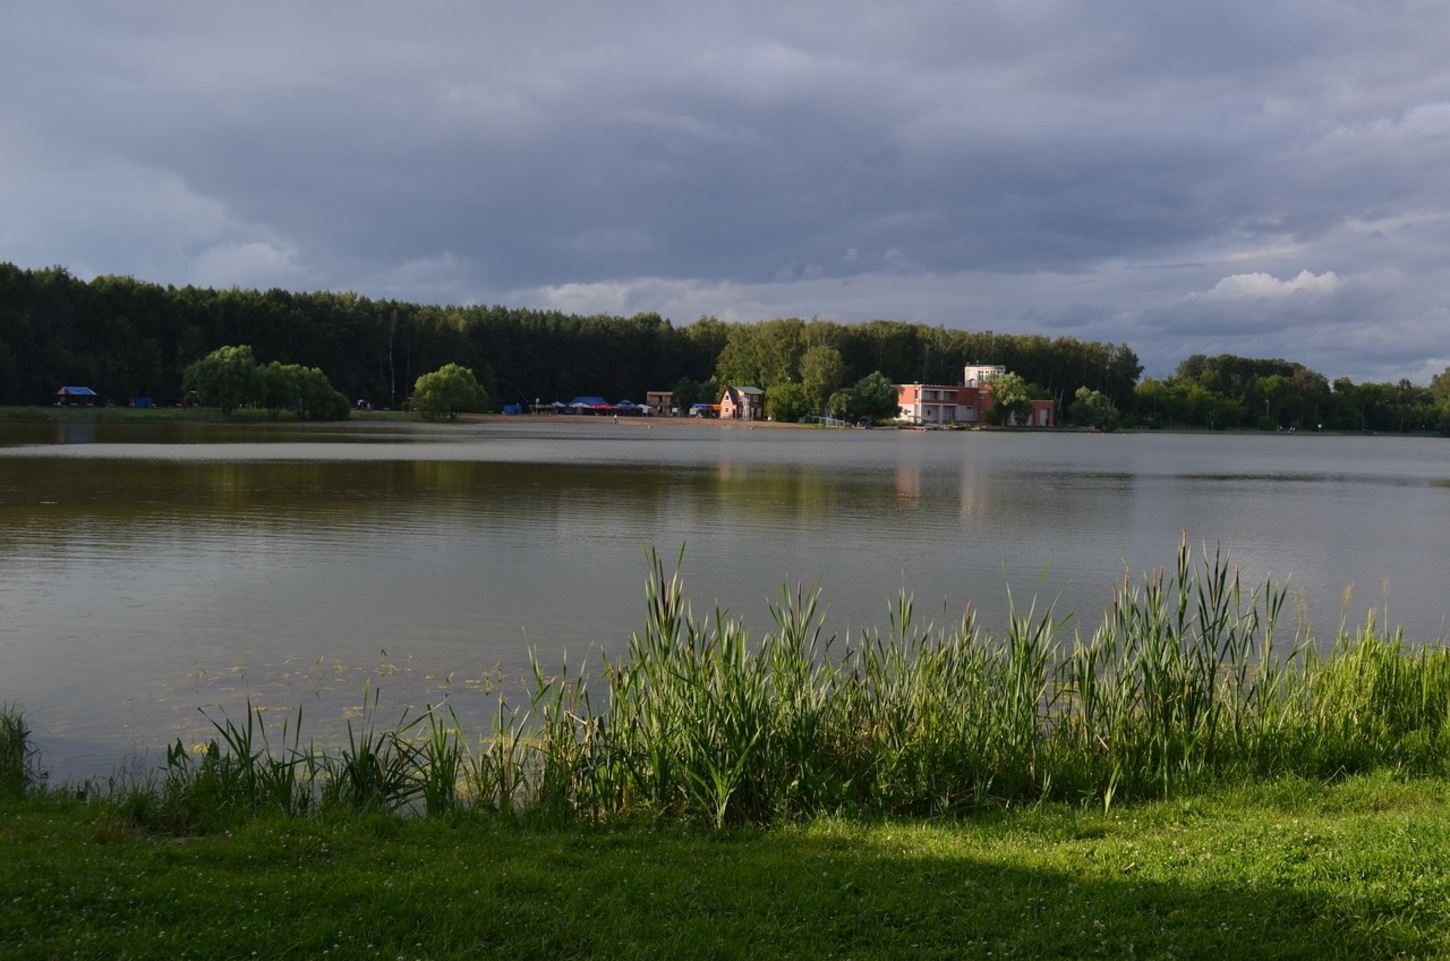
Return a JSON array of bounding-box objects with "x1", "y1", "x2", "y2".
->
[{"x1": 0, "y1": 264, "x2": 1450, "y2": 430}]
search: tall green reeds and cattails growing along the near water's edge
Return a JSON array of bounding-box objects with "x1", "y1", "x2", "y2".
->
[{"x1": 42, "y1": 539, "x2": 1450, "y2": 829}]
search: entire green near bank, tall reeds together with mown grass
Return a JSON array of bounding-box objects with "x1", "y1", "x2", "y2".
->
[{"x1": 8, "y1": 544, "x2": 1450, "y2": 960}]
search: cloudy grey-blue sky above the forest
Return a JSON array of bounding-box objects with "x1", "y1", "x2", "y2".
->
[{"x1": 0, "y1": 0, "x2": 1450, "y2": 384}]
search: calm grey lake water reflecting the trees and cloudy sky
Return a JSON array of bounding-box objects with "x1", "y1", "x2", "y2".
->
[{"x1": 0, "y1": 420, "x2": 1450, "y2": 777}]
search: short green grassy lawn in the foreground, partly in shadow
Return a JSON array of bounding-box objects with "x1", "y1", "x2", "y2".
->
[{"x1": 0, "y1": 775, "x2": 1450, "y2": 961}]
